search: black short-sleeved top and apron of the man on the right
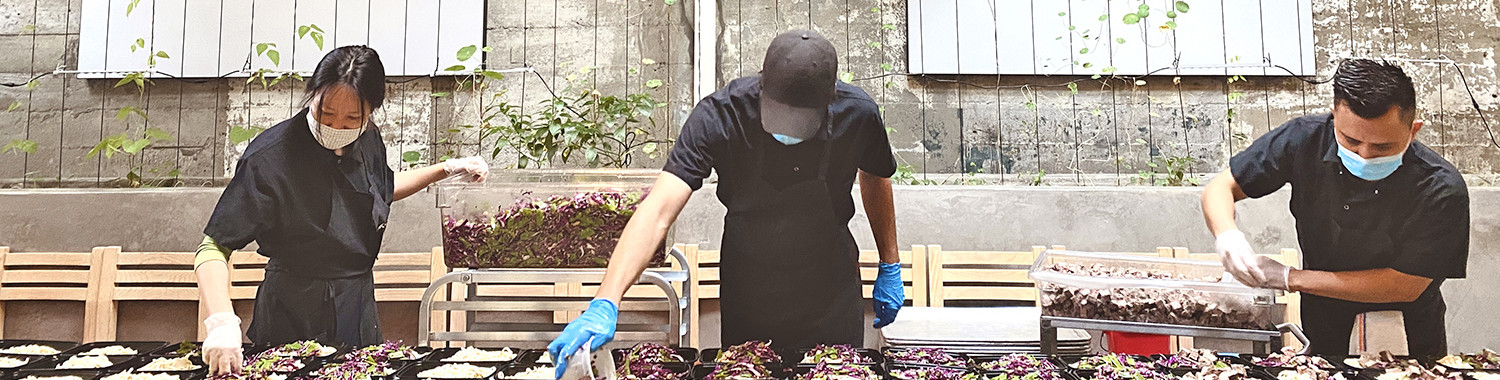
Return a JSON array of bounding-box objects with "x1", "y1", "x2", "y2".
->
[{"x1": 1230, "y1": 114, "x2": 1469, "y2": 356}]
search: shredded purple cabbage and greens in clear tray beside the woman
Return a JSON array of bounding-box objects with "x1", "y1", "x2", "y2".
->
[{"x1": 443, "y1": 191, "x2": 666, "y2": 267}]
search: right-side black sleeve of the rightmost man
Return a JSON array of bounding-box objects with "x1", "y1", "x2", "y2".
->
[{"x1": 1391, "y1": 182, "x2": 1469, "y2": 279}]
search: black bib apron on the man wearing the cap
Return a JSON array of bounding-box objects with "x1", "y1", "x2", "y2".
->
[{"x1": 720, "y1": 129, "x2": 864, "y2": 353}]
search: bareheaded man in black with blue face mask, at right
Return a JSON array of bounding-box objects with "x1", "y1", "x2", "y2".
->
[{"x1": 1203, "y1": 60, "x2": 1469, "y2": 357}]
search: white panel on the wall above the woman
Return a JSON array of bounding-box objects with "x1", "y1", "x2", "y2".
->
[{"x1": 78, "y1": 0, "x2": 486, "y2": 78}]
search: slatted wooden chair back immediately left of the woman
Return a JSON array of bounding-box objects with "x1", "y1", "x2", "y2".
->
[{"x1": 92, "y1": 246, "x2": 206, "y2": 341}]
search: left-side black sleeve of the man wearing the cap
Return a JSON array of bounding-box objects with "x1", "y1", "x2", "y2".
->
[{"x1": 662, "y1": 99, "x2": 728, "y2": 191}]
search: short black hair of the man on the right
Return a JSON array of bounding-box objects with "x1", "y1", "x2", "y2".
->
[{"x1": 1334, "y1": 59, "x2": 1416, "y2": 120}]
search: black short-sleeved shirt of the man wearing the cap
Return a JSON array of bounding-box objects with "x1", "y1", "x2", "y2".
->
[{"x1": 663, "y1": 75, "x2": 896, "y2": 217}]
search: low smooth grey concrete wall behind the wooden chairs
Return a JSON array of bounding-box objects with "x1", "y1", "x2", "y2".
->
[{"x1": 0, "y1": 186, "x2": 1500, "y2": 351}]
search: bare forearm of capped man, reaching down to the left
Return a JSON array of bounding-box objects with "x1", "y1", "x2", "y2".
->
[{"x1": 594, "y1": 171, "x2": 693, "y2": 305}]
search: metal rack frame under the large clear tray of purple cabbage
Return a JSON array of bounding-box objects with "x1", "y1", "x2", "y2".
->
[{"x1": 417, "y1": 248, "x2": 693, "y2": 347}]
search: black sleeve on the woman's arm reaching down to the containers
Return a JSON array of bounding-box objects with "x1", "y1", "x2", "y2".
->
[{"x1": 203, "y1": 159, "x2": 276, "y2": 249}]
